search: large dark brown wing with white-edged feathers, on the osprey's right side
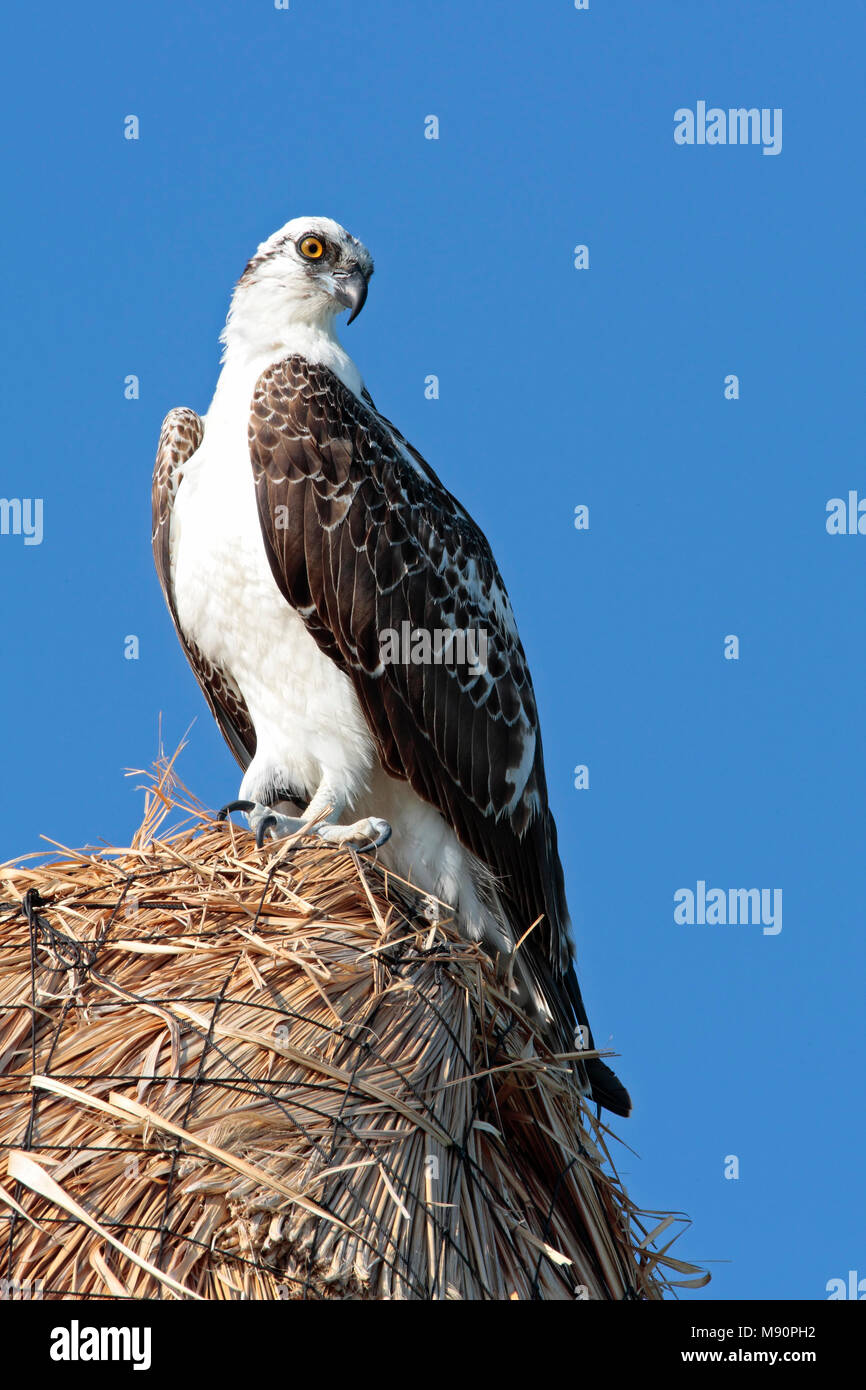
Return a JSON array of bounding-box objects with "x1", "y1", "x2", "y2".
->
[{"x1": 250, "y1": 356, "x2": 570, "y2": 973}]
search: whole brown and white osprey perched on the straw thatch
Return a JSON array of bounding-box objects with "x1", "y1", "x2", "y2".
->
[{"x1": 153, "y1": 217, "x2": 631, "y2": 1115}]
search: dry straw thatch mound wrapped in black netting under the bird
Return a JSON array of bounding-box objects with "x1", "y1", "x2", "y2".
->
[{"x1": 0, "y1": 762, "x2": 708, "y2": 1300}]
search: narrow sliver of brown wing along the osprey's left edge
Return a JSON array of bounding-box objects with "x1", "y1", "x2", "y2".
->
[{"x1": 152, "y1": 407, "x2": 256, "y2": 769}]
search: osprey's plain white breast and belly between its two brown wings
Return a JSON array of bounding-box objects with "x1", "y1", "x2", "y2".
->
[{"x1": 171, "y1": 358, "x2": 374, "y2": 802}]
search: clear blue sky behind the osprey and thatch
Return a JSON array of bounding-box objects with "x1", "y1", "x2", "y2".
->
[{"x1": 0, "y1": 0, "x2": 866, "y2": 1300}]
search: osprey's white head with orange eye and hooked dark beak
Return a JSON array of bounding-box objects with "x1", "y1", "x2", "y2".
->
[{"x1": 222, "y1": 217, "x2": 373, "y2": 353}]
